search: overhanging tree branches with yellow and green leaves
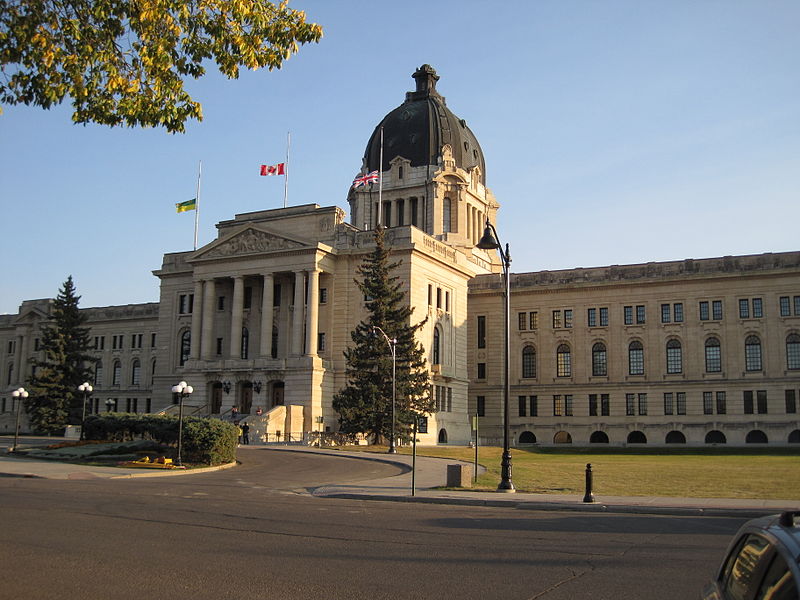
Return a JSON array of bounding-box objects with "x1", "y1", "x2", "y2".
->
[{"x1": 0, "y1": 0, "x2": 322, "y2": 133}]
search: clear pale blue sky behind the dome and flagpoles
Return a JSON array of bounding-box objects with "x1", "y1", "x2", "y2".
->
[{"x1": 0, "y1": 0, "x2": 800, "y2": 313}]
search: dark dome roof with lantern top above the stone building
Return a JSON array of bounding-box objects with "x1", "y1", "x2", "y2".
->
[{"x1": 364, "y1": 65, "x2": 486, "y2": 184}]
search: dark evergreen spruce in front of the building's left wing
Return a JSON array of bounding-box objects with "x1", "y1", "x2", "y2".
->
[{"x1": 25, "y1": 275, "x2": 95, "y2": 433}]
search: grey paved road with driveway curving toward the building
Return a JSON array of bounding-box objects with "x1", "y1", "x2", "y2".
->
[{"x1": 0, "y1": 448, "x2": 741, "y2": 600}]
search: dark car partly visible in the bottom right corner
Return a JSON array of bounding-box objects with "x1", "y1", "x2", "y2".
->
[{"x1": 702, "y1": 511, "x2": 800, "y2": 600}]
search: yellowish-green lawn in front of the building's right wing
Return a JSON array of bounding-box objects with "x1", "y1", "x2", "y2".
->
[{"x1": 340, "y1": 446, "x2": 800, "y2": 500}]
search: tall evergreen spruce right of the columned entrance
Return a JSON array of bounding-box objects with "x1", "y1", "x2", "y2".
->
[{"x1": 333, "y1": 227, "x2": 433, "y2": 443}]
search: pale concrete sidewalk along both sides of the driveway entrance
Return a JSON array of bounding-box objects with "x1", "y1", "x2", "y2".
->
[{"x1": 0, "y1": 445, "x2": 800, "y2": 519}]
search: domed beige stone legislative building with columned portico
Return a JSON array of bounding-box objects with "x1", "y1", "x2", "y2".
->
[{"x1": 0, "y1": 65, "x2": 800, "y2": 445}]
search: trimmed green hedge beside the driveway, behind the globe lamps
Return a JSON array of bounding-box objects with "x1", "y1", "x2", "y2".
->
[{"x1": 84, "y1": 413, "x2": 239, "y2": 465}]
